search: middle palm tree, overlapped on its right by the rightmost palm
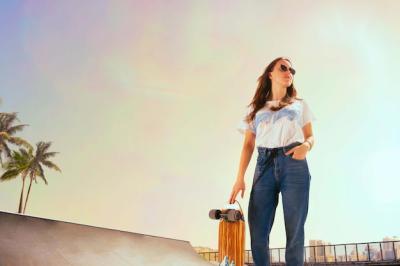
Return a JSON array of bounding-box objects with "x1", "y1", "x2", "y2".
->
[{"x1": 0, "y1": 148, "x2": 33, "y2": 213}]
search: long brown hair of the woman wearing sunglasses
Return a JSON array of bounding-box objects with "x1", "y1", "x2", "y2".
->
[{"x1": 246, "y1": 57, "x2": 301, "y2": 122}]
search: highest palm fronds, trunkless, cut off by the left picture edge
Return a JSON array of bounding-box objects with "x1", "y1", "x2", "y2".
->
[{"x1": 0, "y1": 113, "x2": 32, "y2": 166}]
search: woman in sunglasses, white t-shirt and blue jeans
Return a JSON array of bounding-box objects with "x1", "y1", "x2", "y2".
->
[{"x1": 229, "y1": 57, "x2": 315, "y2": 266}]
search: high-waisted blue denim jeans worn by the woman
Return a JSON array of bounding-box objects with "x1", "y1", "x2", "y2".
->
[{"x1": 248, "y1": 142, "x2": 311, "y2": 266}]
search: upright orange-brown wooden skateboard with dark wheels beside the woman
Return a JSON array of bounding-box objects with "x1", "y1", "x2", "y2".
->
[{"x1": 209, "y1": 201, "x2": 245, "y2": 266}]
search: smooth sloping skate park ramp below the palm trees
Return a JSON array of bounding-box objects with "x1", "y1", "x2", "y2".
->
[{"x1": 0, "y1": 211, "x2": 212, "y2": 266}]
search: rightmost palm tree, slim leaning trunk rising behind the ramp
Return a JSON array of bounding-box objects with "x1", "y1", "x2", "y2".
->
[{"x1": 23, "y1": 141, "x2": 61, "y2": 213}]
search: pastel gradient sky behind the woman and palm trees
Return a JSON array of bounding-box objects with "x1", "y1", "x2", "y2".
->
[{"x1": 0, "y1": 0, "x2": 400, "y2": 249}]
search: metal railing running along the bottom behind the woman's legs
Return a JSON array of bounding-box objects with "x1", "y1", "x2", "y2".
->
[{"x1": 199, "y1": 240, "x2": 400, "y2": 265}]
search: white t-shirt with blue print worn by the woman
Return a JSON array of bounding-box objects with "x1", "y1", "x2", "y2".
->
[{"x1": 237, "y1": 99, "x2": 316, "y2": 148}]
